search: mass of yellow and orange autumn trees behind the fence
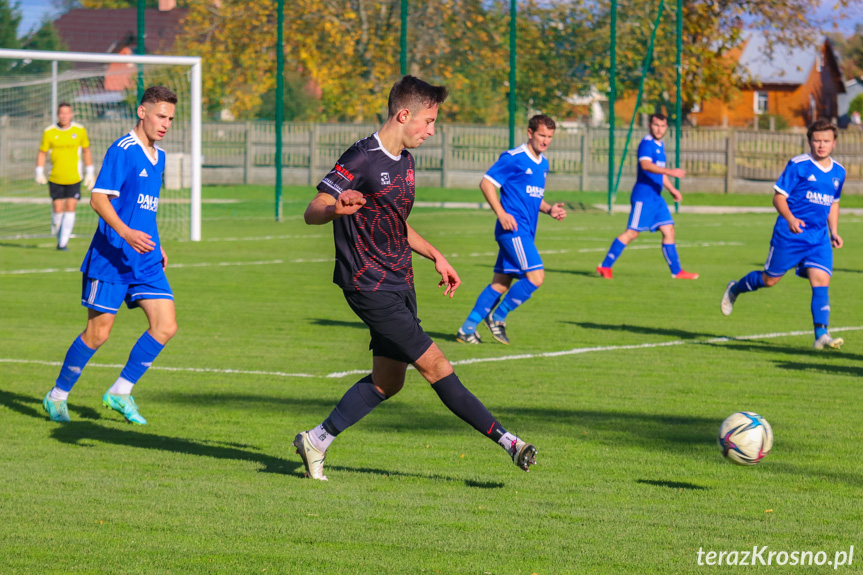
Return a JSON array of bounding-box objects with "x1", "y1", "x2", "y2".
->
[{"x1": 169, "y1": 0, "x2": 851, "y2": 124}]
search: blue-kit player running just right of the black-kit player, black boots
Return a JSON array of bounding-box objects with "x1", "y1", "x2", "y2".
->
[{"x1": 456, "y1": 114, "x2": 566, "y2": 345}]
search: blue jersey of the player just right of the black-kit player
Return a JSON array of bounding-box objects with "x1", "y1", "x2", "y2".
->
[{"x1": 485, "y1": 144, "x2": 548, "y2": 238}]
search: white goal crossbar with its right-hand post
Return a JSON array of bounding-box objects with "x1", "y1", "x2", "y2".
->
[{"x1": 0, "y1": 48, "x2": 203, "y2": 242}]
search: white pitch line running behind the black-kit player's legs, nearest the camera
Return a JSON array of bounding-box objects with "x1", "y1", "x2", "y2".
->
[{"x1": 0, "y1": 326, "x2": 863, "y2": 379}]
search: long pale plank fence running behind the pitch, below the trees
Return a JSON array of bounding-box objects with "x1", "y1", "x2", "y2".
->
[{"x1": 0, "y1": 118, "x2": 863, "y2": 193}]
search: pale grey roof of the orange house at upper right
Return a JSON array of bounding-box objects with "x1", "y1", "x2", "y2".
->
[{"x1": 738, "y1": 32, "x2": 823, "y2": 84}]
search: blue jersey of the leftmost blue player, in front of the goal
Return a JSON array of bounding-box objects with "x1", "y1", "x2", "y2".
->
[{"x1": 81, "y1": 131, "x2": 165, "y2": 284}]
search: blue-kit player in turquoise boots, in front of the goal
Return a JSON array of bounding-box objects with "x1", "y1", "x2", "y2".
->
[{"x1": 42, "y1": 86, "x2": 177, "y2": 425}]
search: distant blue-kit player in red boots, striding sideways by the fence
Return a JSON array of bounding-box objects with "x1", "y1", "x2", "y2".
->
[{"x1": 596, "y1": 114, "x2": 698, "y2": 280}]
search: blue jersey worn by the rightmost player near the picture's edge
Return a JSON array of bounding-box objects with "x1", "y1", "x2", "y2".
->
[{"x1": 773, "y1": 154, "x2": 845, "y2": 239}]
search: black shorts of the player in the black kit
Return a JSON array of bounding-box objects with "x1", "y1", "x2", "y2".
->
[{"x1": 345, "y1": 290, "x2": 434, "y2": 363}]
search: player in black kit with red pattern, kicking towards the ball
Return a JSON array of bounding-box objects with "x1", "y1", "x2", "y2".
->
[{"x1": 294, "y1": 76, "x2": 536, "y2": 481}]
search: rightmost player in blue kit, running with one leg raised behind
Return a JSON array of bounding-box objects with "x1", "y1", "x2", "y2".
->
[{"x1": 719, "y1": 120, "x2": 845, "y2": 349}]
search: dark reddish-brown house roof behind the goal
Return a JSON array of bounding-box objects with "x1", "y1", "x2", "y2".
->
[{"x1": 54, "y1": 8, "x2": 189, "y2": 54}]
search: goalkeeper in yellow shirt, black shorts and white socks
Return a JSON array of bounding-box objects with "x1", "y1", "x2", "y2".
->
[{"x1": 36, "y1": 102, "x2": 96, "y2": 251}]
